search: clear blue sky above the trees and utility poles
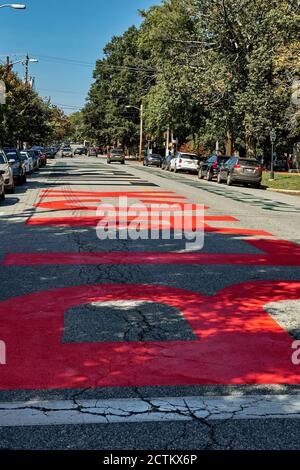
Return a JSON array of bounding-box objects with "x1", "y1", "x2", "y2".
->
[{"x1": 0, "y1": 0, "x2": 161, "y2": 114}]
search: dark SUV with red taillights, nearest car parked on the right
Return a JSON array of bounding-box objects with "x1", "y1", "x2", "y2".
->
[{"x1": 218, "y1": 157, "x2": 263, "y2": 187}]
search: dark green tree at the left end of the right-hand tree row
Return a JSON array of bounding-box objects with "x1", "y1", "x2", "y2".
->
[{"x1": 84, "y1": 27, "x2": 153, "y2": 147}]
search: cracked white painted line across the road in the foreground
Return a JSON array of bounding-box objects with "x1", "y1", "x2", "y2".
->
[{"x1": 0, "y1": 395, "x2": 300, "y2": 427}]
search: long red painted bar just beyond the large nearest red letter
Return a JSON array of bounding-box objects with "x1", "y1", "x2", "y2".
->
[{"x1": 3, "y1": 240, "x2": 300, "y2": 266}]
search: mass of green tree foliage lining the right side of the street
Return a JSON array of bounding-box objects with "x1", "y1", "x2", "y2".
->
[{"x1": 84, "y1": 0, "x2": 300, "y2": 155}]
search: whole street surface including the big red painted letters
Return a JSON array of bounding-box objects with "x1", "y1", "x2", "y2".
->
[{"x1": 0, "y1": 157, "x2": 300, "y2": 450}]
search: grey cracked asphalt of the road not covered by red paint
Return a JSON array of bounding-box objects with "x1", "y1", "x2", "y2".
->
[{"x1": 0, "y1": 158, "x2": 300, "y2": 450}]
